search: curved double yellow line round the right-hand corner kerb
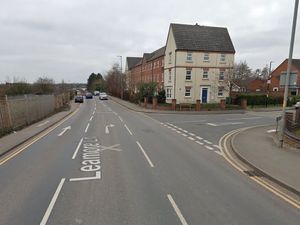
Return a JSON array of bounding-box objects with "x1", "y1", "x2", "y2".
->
[{"x1": 219, "y1": 127, "x2": 300, "y2": 209}]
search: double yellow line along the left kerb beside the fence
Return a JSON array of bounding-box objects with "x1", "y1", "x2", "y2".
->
[{"x1": 0, "y1": 108, "x2": 79, "y2": 166}]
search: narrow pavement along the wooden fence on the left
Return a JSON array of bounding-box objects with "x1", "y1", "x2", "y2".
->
[{"x1": 0, "y1": 102, "x2": 79, "y2": 156}]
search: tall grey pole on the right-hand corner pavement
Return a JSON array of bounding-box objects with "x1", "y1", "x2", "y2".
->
[{"x1": 280, "y1": 0, "x2": 299, "y2": 147}]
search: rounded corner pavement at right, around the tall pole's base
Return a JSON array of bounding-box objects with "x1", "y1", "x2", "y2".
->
[{"x1": 231, "y1": 125, "x2": 300, "y2": 195}]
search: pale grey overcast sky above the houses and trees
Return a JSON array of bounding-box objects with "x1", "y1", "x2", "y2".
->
[{"x1": 0, "y1": 0, "x2": 300, "y2": 82}]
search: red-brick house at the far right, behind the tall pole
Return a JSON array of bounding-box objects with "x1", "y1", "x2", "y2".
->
[{"x1": 267, "y1": 59, "x2": 300, "y2": 95}]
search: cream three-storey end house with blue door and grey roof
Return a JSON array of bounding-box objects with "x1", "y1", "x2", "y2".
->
[{"x1": 164, "y1": 24, "x2": 235, "y2": 103}]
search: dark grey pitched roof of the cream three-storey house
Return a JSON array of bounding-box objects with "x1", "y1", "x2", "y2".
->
[{"x1": 170, "y1": 23, "x2": 235, "y2": 53}]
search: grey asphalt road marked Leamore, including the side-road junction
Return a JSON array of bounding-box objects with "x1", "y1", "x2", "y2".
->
[{"x1": 0, "y1": 99, "x2": 300, "y2": 225}]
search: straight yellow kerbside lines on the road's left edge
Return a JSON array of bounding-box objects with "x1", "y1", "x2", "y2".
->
[{"x1": 0, "y1": 106, "x2": 80, "y2": 166}]
